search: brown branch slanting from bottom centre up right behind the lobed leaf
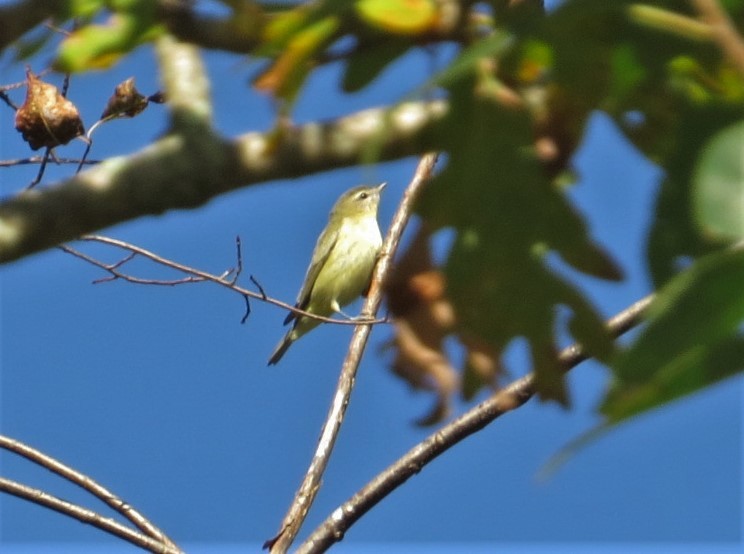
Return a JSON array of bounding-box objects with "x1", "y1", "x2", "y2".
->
[{"x1": 297, "y1": 295, "x2": 653, "y2": 554}]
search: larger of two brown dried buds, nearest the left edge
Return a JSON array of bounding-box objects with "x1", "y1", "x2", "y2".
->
[{"x1": 15, "y1": 69, "x2": 84, "y2": 150}]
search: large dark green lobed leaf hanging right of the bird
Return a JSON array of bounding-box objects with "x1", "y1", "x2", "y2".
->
[{"x1": 418, "y1": 74, "x2": 619, "y2": 404}]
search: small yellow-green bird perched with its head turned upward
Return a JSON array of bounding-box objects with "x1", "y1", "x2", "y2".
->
[{"x1": 269, "y1": 183, "x2": 386, "y2": 365}]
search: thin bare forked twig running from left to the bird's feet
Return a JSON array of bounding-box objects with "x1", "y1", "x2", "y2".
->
[{"x1": 58, "y1": 235, "x2": 387, "y2": 325}]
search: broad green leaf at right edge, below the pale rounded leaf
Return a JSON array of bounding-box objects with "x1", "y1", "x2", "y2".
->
[{"x1": 602, "y1": 250, "x2": 744, "y2": 422}]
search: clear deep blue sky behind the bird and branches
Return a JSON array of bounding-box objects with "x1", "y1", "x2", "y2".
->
[{"x1": 0, "y1": 1, "x2": 742, "y2": 553}]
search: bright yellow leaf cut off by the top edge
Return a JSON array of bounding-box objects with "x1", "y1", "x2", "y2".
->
[{"x1": 355, "y1": 0, "x2": 437, "y2": 35}]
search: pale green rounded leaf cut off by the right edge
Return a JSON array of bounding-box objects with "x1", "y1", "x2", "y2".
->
[{"x1": 693, "y1": 121, "x2": 744, "y2": 239}]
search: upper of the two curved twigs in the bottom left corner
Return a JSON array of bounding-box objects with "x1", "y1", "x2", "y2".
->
[{"x1": 0, "y1": 435, "x2": 178, "y2": 550}]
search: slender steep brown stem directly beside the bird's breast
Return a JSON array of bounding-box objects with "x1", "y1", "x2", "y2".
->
[{"x1": 264, "y1": 154, "x2": 437, "y2": 553}]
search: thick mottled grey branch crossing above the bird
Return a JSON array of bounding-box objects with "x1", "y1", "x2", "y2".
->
[{"x1": 0, "y1": 101, "x2": 446, "y2": 263}]
